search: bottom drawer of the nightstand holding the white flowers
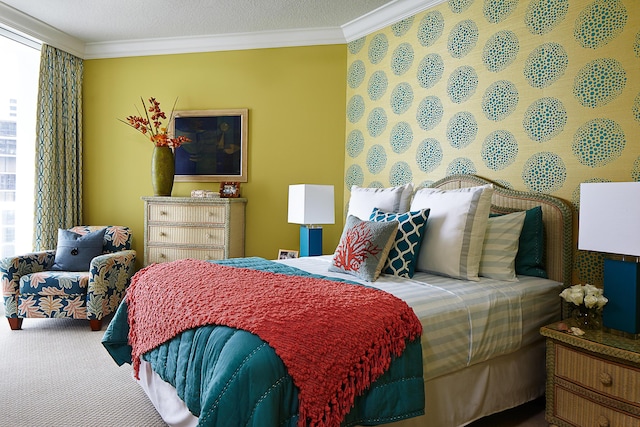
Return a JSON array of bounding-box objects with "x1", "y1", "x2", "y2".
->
[{"x1": 554, "y1": 387, "x2": 640, "y2": 427}]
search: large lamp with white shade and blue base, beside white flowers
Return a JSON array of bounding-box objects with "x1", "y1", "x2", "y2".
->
[{"x1": 578, "y1": 182, "x2": 640, "y2": 335}]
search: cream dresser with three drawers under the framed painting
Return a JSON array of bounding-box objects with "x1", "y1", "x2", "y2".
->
[{"x1": 142, "y1": 197, "x2": 246, "y2": 265}]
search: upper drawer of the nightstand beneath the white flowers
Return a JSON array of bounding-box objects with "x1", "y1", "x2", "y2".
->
[{"x1": 555, "y1": 345, "x2": 640, "y2": 405}]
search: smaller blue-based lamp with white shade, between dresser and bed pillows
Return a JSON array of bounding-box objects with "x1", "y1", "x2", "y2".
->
[{"x1": 288, "y1": 184, "x2": 335, "y2": 256}]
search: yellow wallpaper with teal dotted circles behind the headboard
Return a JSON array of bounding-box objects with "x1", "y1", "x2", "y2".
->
[{"x1": 345, "y1": 0, "x2": 640, "y2": 283}]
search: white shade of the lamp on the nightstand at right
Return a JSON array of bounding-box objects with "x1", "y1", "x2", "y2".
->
[{"x1": 578, "y1": 182, "x2": 640, "y2": 256}]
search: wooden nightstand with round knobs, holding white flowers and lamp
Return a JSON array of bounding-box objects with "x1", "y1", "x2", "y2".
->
[{"x1": 540, "y1": 322, "x2": 640, "y2": 427}]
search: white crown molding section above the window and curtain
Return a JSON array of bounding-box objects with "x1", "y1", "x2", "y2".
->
[{"x1": 0, "y1": 2, "x2": 84, "y2": 58}]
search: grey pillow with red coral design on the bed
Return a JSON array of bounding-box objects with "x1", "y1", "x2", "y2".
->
[{"x1": 329, "y1": 215, "x2": 398, "y2": 282}]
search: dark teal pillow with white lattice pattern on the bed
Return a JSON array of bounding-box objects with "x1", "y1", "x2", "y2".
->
[{"x1": 369, "y1": 208, "x2": 429, "y2": 278}]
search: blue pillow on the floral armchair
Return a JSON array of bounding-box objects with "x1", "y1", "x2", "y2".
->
[{"x1": 51, "y1": 228, "x2": 107, "y2": 271}]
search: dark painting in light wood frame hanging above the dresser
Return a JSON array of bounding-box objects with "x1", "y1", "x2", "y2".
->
[{"x1": 169, "y1": 108, "x2": 249, "y2": 182}]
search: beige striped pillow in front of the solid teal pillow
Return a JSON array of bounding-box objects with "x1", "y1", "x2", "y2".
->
[{"x1": 479, "y1": 211, "x2": 526, "y2": 282}]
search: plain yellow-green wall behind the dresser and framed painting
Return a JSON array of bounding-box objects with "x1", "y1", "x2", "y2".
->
[{"x1": 83, "y1": 45, "x2": 347, "y2": 265}]
